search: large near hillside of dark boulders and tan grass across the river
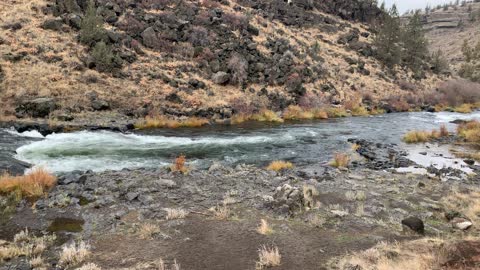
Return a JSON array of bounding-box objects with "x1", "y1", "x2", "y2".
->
[{"x1": 0, "y1": 0, "x2": 438, "y2": 121}]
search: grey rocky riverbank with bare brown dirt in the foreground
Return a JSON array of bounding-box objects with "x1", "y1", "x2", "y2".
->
[{"x1": 0, "y1": 137, "x2": 480, "y2": 269}]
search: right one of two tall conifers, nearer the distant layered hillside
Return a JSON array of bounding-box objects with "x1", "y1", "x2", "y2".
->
[{"x1": 402, "y1": 12, "x2": 429, "y2": 78}]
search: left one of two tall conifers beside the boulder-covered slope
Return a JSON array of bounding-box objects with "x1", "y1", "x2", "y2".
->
[{"x1": 374, "y1": 5, "x2": 401, "y2": 68}]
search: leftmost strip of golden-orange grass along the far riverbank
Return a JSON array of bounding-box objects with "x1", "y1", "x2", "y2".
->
[{"x1": 135, "y1": 115, "x2": 210, "y2": 129}]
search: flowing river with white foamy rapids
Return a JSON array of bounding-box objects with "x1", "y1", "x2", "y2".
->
[{"x1": 0, "y1": 112, "x2": 480, "y2": 172}]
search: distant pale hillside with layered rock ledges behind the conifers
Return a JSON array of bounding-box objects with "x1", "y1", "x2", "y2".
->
[{"x1": 412, "y1": 2, "x2": 480, "y2": 72}]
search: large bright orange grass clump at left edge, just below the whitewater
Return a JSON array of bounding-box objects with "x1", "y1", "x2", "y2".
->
[{"x1": 0, "y1": 168, "x2": 57, "y2": 200}]
